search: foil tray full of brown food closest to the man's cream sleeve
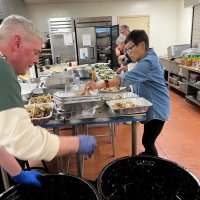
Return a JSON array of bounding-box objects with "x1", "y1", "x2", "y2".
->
[{"x1": 24, "y1": 103, "x2": 54, "y2": 125}]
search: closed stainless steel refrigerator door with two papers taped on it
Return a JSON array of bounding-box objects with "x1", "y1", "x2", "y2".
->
[{"x1": 76, "y1": 27, "x2": 97, "y2": 65}]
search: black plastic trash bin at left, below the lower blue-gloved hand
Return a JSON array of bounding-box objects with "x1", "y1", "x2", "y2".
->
[{"x1": 0, "y1": 174, "x2": 101, "y2": 200}]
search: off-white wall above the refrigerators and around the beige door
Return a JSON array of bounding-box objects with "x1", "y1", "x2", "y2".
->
[{"x1": 27, "y1": 0, "x2": 192, "y2": 55}]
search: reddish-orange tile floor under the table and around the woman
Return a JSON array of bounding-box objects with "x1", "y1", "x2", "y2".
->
[{"x1": 37, "y1": 90, "x2": 200, "y2": 180}]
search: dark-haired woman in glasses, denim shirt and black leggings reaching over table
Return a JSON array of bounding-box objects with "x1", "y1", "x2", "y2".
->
[{"x1": 85, "y1": 30, "x2": 170, "y2": 156}]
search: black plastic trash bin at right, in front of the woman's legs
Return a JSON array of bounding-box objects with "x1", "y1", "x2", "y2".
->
[{"x1": 97, "y1": 156, "x2": 200, "y2": 200}]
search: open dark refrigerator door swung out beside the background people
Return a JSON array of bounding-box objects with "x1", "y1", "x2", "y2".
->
[{"x1": 111, "y1": 25, "x2": 119, "y2": 69}]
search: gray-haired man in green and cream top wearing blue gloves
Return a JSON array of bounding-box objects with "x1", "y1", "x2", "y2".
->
[{"x1": 0, "y1": 15, "x2": 96, "y2": 186}]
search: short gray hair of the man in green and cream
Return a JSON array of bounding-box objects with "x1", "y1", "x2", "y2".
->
[{"x1": 0, "y1": 15, "x2": 43, "y2": 40}]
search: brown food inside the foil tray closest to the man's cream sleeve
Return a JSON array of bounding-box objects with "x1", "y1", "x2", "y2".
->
[{"x1": 26, "y1": 104, "x2": 52, "y2": 119}]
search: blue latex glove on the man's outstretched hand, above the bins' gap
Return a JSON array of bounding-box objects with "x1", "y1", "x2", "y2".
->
[{"x1": 77, "y1": 135, "x2": 97, "y2": 156}]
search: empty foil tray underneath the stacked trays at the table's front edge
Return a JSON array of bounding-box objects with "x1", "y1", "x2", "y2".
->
[{"x1": 58, "y1": 107, "x2": 96, "y2": 119}]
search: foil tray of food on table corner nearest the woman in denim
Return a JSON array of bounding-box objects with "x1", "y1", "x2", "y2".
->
[{"x1": 106, "y1": 97, "x2": 152, "y2": 115}]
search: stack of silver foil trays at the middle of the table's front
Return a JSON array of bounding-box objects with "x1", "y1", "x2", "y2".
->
[{"x1": 54, "y1": 91, "x2": 101, "y2": 113}]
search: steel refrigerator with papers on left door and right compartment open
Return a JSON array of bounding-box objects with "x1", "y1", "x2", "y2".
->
[{"x1": 75, "y1": 16, "x2": 112, "y2": 64}]
